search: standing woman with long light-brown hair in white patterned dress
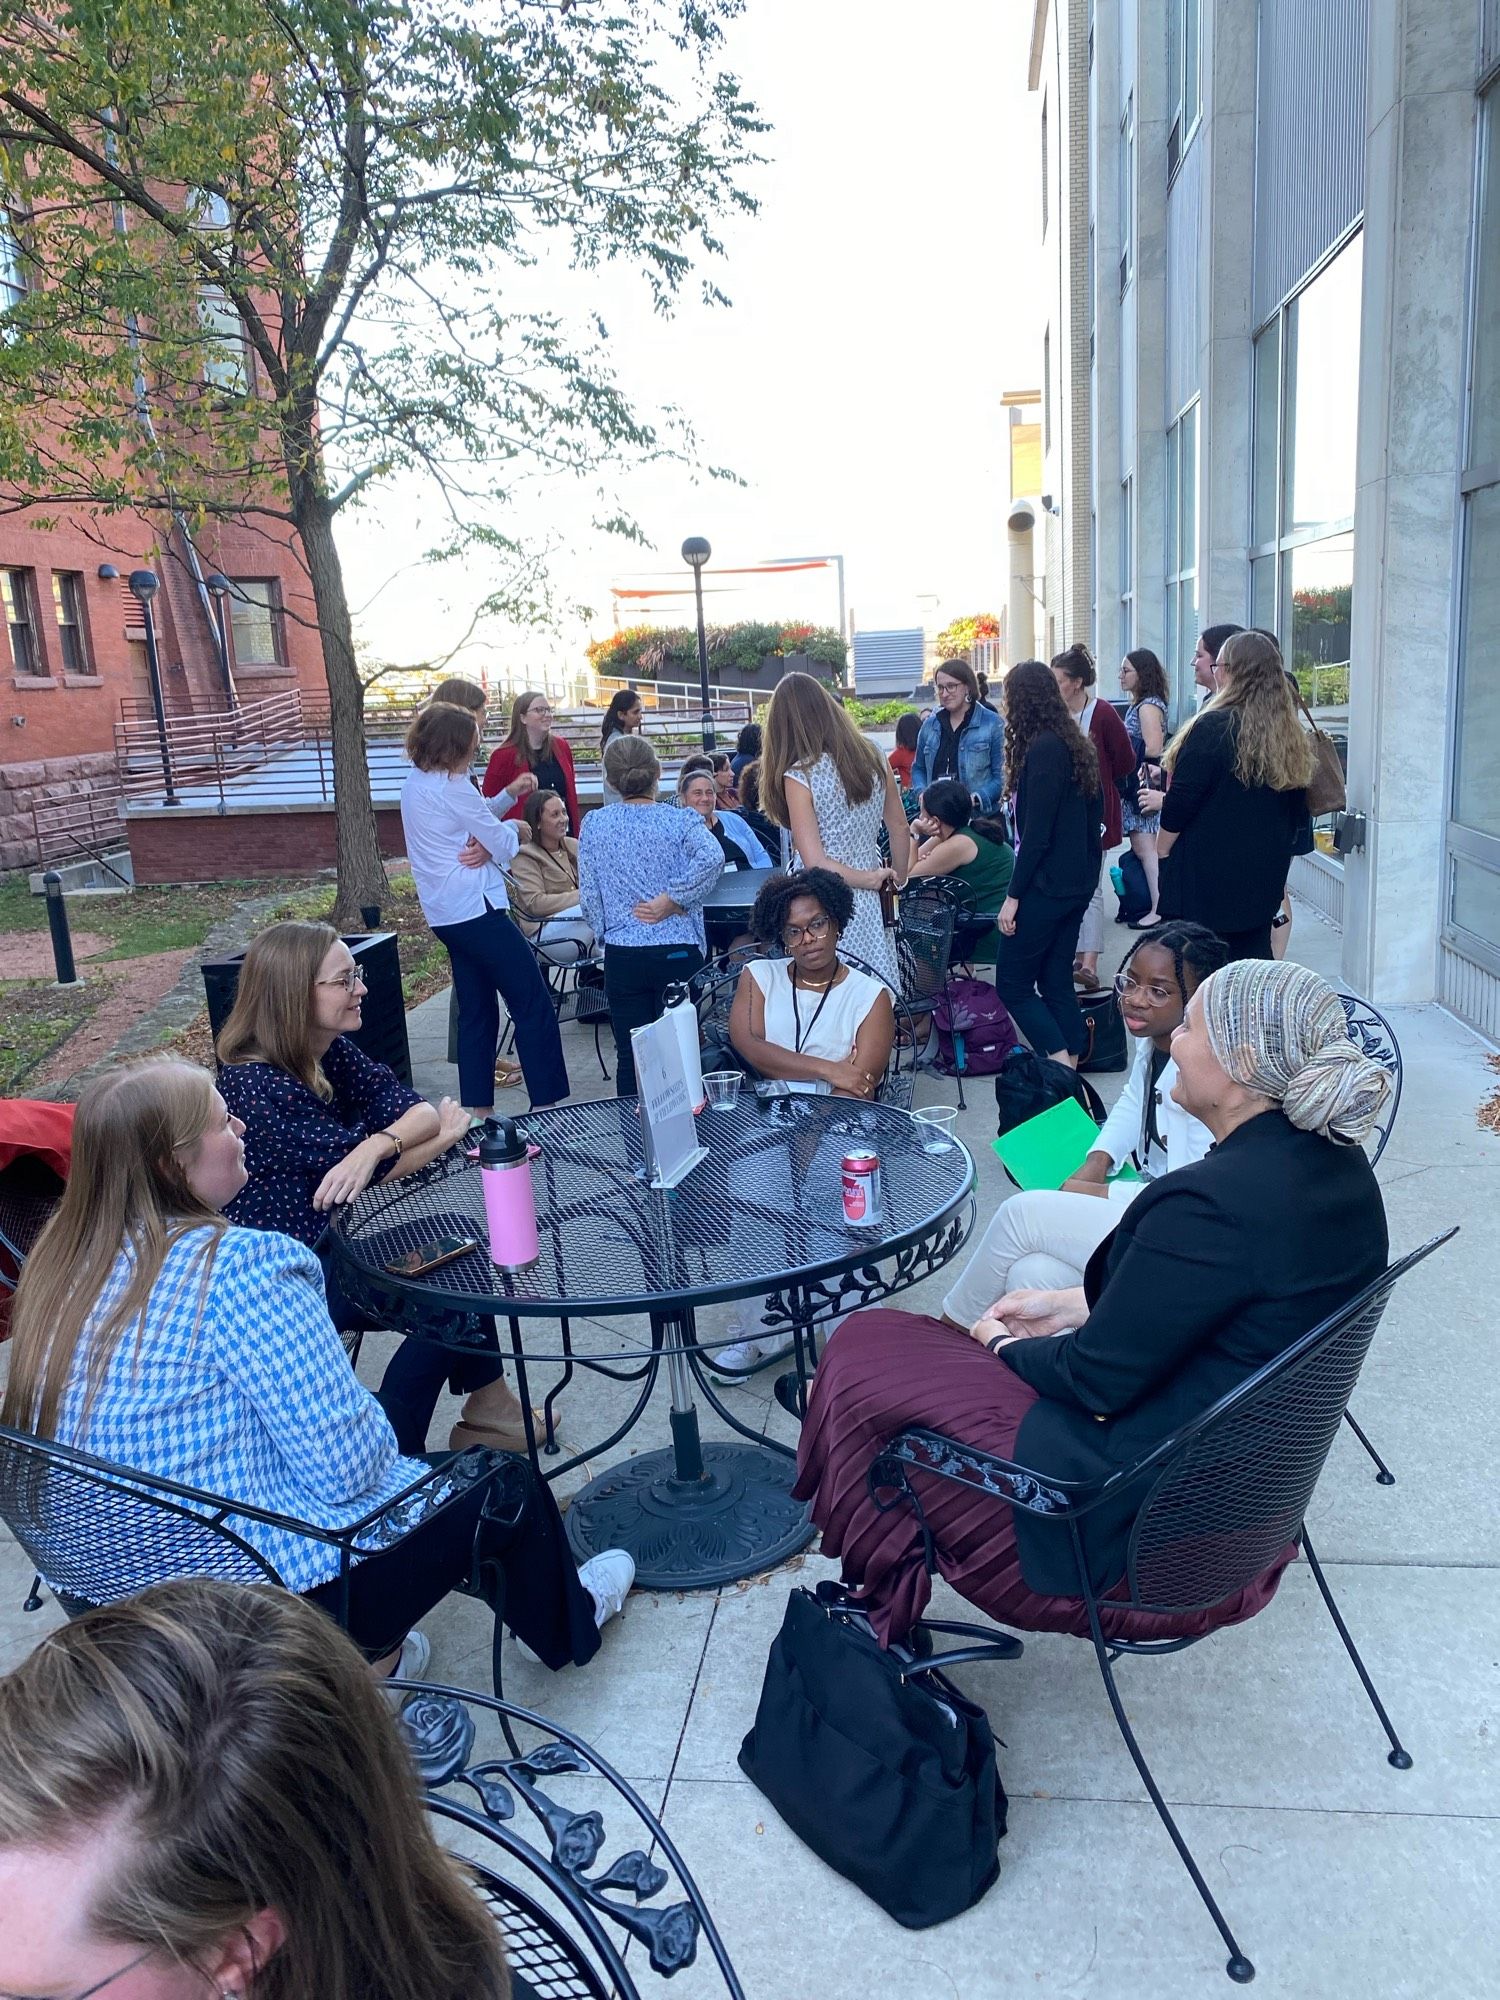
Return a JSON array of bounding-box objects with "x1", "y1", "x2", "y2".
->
[{"x1": 760, "y1": 674, "x2": 912, "y2": 990}]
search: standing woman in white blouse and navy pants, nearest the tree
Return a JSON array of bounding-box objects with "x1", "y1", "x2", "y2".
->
[{"x1": 402, "y1": 702, "x2": 568, "y2": 1118}]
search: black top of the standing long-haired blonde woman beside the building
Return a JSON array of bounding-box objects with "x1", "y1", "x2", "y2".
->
[{"x1": 1158, "y1": 708, "x2": 1308, "y2": 932}]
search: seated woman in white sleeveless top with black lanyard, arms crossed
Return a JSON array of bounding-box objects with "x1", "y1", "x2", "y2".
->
[{"x1": 730, "y1": 868, "x2": 896, "y2": 1098}]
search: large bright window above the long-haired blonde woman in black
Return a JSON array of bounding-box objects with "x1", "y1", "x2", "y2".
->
[{"x1": 1250, "y1": 234, "x2": 1364, "y2": 860}]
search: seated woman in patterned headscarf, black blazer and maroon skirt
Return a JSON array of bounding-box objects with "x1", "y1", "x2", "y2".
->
[{"x1": 794, "y1": 960, "x2": 1390, "y2": 1644}]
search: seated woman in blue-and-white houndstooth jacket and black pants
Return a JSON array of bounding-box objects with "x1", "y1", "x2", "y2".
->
[{"x1": 0, "y1": 1062, "x2": 634, "y2": 1676}]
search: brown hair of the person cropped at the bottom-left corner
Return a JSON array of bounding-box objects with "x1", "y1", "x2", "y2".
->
[{"x1": 0, "y1": 1578, "x2": 510, "y2": 2000}]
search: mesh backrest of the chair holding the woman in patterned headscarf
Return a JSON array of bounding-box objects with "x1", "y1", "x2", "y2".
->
[{"x1": 1126, "y1": 1230, "x2": 1454, "y2": 1612}]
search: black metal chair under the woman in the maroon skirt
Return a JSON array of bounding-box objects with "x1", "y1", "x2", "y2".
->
[{"x1": 868, "y1": 1230, "x2": 1458, "y2": 1984}]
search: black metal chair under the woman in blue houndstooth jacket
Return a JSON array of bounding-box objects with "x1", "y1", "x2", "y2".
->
[{"x1": 0, "y1": 1426, "x2": 518, "y2": 1686}]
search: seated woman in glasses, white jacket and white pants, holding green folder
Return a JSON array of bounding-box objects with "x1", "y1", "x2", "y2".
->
[{"x1": 942, "y1": 924, "x2": 1228, "y2": 1330}]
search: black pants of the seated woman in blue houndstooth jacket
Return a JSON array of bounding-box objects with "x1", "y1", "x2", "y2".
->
[{"x1": 302, "y1": 1454, "x2": 600, "y2": 1668}]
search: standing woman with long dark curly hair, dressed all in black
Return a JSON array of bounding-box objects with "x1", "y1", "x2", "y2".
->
[{"x1": 994, "y1": 660, "x2": 1102, "y2": 1066}]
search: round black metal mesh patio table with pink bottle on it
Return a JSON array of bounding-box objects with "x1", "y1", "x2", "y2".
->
[{"x1": 334, "y1": 1094, "x2": 974, "y2": 1590}]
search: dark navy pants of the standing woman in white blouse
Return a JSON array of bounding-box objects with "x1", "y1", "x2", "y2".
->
[{"x1": 432, "y1": 910, "x2": 568, "y2": 1110}]
